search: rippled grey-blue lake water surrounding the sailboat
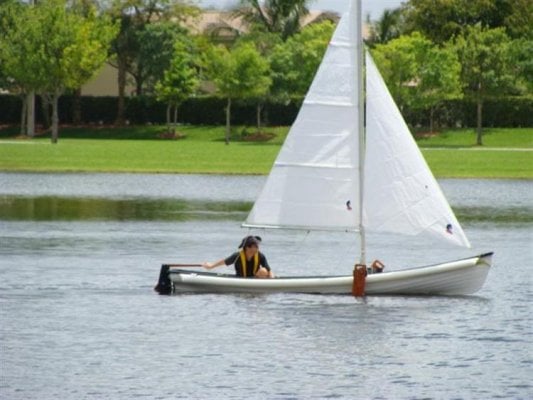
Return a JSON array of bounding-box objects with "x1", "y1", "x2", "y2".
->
[{"x1": 0, "y1": 173, "x2": 533, "y2": 399}]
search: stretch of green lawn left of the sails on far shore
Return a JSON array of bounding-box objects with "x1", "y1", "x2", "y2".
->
[{"x1": 0, "y1": 126, "x2": 287, "y2": 174}]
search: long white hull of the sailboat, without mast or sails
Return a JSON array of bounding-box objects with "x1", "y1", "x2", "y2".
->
[{"x1": 156, "y1": 253, "x2": 492, "y2": 295}]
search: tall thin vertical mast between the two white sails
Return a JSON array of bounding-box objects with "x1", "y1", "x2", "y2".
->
[{"x1": 355, "y1": 0, "x2": 366, "y2": 265}]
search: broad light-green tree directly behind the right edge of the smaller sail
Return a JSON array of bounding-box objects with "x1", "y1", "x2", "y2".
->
[{"x1": 373, "y1": 32, "x2": 462, "y2": 132}]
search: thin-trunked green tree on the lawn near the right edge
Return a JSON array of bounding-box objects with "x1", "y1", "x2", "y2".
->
[{"x1": 455, "y1": 24, "x2": 515, "y2": 145}]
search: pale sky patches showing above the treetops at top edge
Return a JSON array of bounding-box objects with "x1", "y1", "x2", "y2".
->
[{"x1": 197, "y1": 0, "x2": 404, "y2": 20}]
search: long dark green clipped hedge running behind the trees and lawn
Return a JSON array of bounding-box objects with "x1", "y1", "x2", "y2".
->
[{"x1": 0, "y1": 95, "x2": 533, "y2": 127}]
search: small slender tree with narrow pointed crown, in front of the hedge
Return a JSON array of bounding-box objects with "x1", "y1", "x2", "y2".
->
[{"x1": 155, "y1": 40, "x2": 199, "y2": 135}]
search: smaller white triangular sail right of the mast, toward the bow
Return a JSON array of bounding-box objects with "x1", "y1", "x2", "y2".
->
[{"x1": 363, "y1": 54, "x2": 470, "y2": 247}]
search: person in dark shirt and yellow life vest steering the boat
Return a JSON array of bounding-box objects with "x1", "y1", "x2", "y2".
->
[{"x1": 202, "y1": 236, "x2": 274, "y2": 278}]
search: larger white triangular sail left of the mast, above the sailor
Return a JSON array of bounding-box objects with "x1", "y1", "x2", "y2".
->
[{"x1": 244, "y1": 1, "x2": 361, "y2": 230}]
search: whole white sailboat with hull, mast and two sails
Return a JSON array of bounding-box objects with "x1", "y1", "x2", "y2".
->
[{"x1": 156, "y1": 0, "x2": 493, "y2": 296}]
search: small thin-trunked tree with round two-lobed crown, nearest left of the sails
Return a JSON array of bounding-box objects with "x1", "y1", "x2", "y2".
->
[{"x1": 203, "y1": 43, "x2": 271, "y2": 144}]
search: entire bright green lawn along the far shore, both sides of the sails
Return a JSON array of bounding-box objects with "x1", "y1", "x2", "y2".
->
[{"x1": 0, "y1": 126, "x2": 533, "y2": 179}]
